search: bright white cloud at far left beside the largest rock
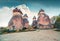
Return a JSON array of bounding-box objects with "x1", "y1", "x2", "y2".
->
[{"x1": 0, "y1": 7, "x2": 13, "y2": 26}]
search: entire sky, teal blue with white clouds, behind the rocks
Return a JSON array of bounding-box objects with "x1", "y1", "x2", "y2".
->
[{"x1": 0, "y1": 0, "x2": 60, "y2": 26}]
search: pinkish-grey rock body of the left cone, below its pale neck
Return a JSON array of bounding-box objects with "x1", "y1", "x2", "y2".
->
[{"x1": 8, "y1": 15, "x2": 22, "y2": 29}]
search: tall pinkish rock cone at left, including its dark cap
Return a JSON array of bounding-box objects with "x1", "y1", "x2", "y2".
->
[{"x1": 8, "y1": 8, "x2": 23, "y2": 30}]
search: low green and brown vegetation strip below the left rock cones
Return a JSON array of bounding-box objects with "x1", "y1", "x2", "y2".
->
[{"x1": 0, "y1": 26, "x2": 35, "y2": 35}]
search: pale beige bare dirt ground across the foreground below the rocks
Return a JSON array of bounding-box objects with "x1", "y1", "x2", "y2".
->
[{"x1": 0, "y1": 30, "x2": 60, "y2": 41}]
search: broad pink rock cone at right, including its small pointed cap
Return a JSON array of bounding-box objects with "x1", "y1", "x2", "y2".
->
[{"x1": 38, "y1": 9, "x2": 51, "y2": 28}]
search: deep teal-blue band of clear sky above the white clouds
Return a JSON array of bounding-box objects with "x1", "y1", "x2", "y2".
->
[{"x1": 0, "y1": 0, "x2": 60, "y2": 11}]
